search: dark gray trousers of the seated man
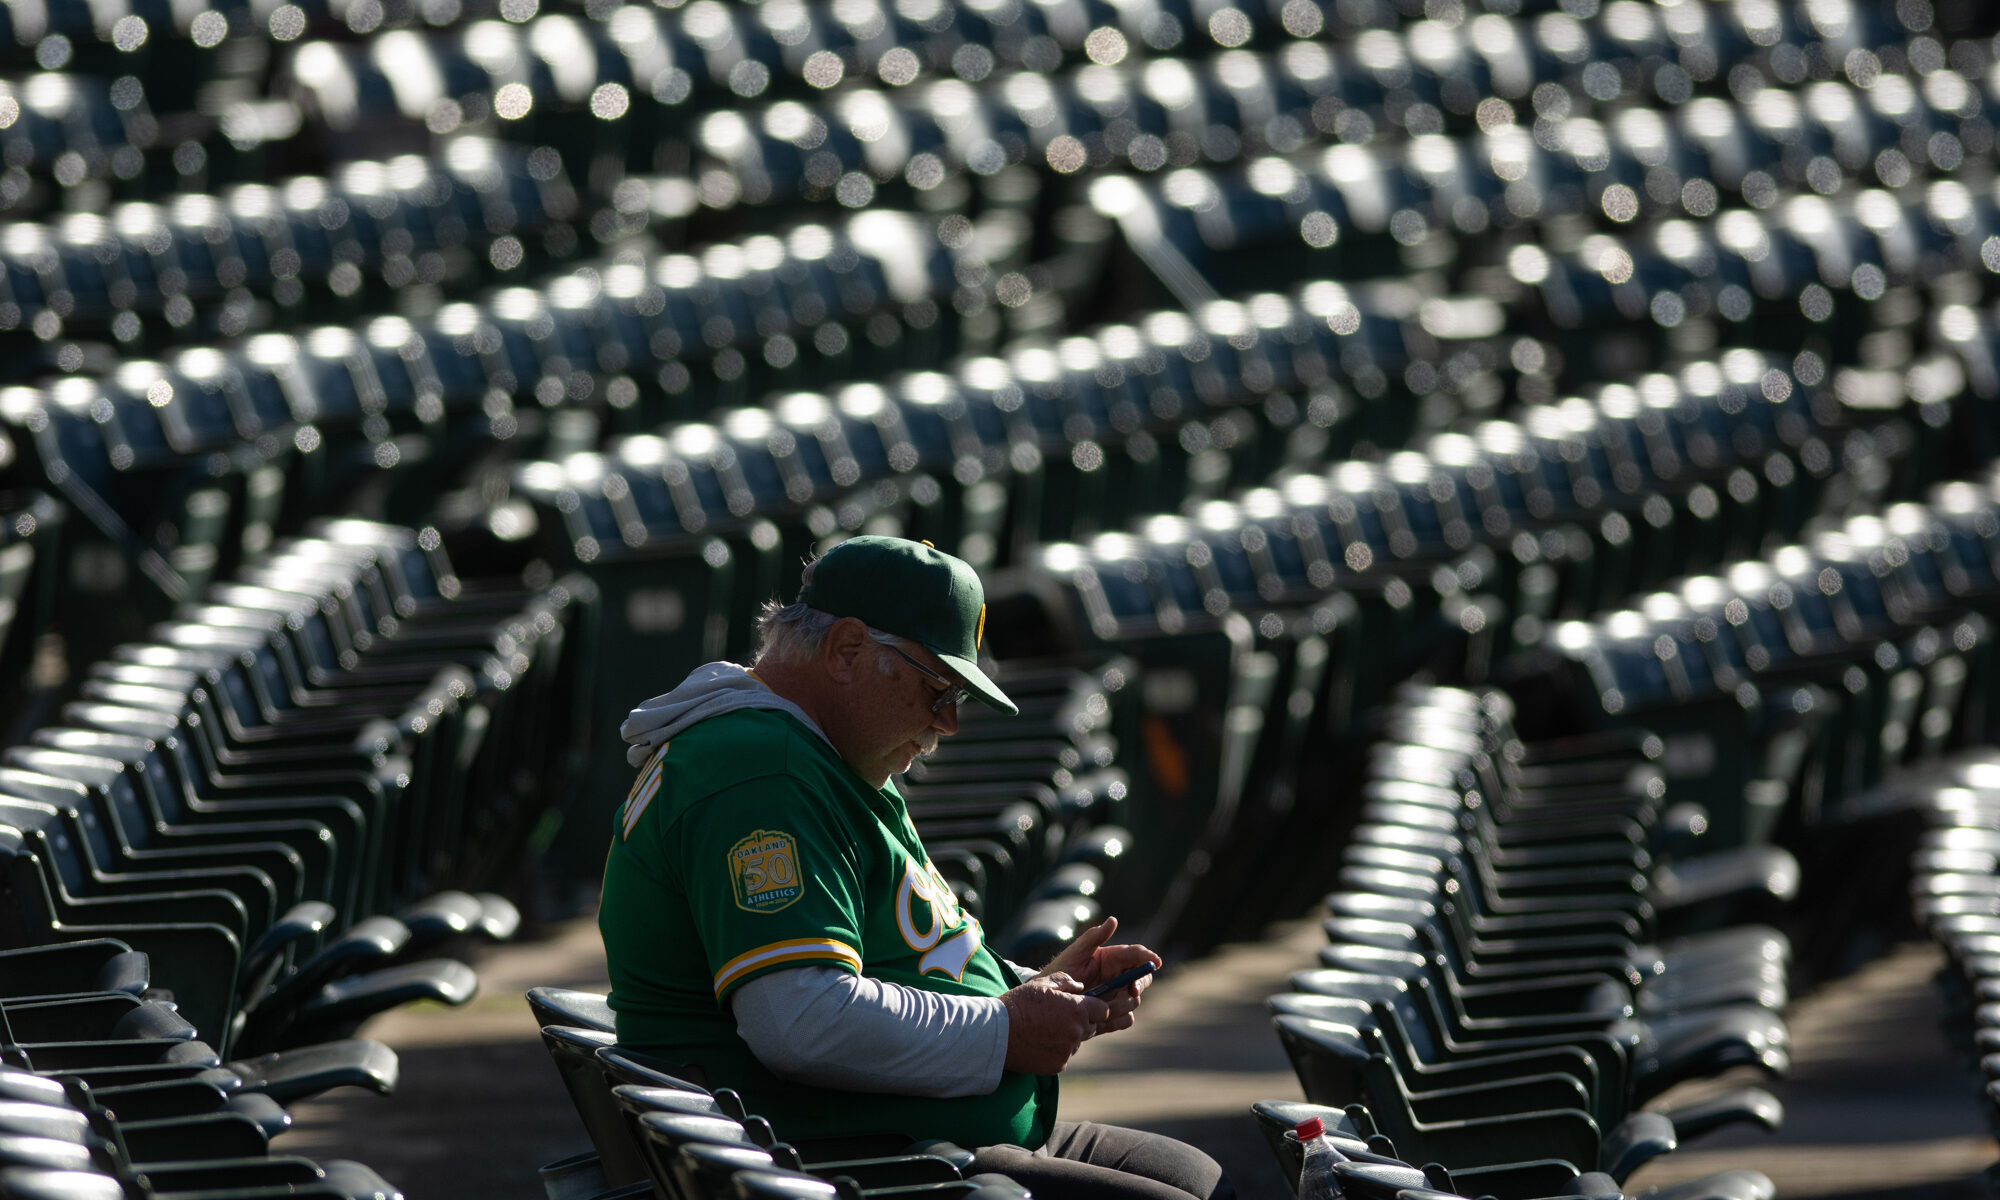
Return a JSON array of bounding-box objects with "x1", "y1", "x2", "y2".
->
[{"x1": 966, "y1": 1120, "x2": 1236, "y2": 1200}]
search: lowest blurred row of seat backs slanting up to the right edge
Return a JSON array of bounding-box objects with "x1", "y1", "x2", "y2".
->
[{"x1": 1508, "y1": 468, "x2": 1994, "y2": 976}]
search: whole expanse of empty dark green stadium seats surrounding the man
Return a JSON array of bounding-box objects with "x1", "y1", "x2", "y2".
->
[{"x1": 0, "y1": 0, "x2": 2000, "y2": 1200}]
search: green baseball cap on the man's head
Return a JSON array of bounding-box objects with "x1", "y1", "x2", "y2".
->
[{"x1": 798, "y1": 536, "x2": 1020, "y2": 716}]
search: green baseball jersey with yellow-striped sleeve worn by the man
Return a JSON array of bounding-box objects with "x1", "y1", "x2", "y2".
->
[{"x1": 598, "y1": 708, "x2": 1056, "y2": 1148}]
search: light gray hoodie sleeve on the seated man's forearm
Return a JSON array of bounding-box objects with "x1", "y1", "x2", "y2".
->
[{"x1": 730, "y1": 966, "x2": 1008, "y2": 1100}]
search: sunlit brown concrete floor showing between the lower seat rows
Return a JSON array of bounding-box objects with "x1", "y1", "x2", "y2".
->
[{"x1": 280, "y1": 918, "x2": 2000, "y2": 1200}]
